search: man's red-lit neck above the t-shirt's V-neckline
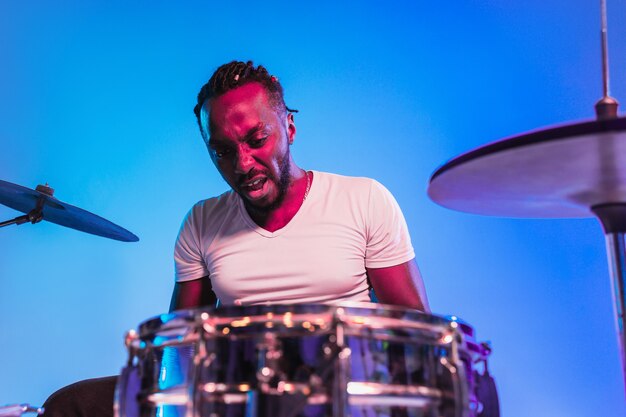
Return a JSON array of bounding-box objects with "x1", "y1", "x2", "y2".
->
[{"x1": 245, "y1": 170, "x2": 310, "y2": 232}]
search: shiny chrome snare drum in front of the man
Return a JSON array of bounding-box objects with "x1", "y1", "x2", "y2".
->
[{"x1": 115, "y1": 304, "x2": 489, "y2": 417}]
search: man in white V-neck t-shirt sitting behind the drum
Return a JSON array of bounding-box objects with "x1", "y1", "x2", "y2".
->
[{"x1": 44, "y1": 61, "x2": 429, "y2": 417}]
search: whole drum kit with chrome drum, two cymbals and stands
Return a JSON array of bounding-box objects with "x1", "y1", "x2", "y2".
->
[{"x1": 0, "y1": 1, "x2": 626, "y2": 417}]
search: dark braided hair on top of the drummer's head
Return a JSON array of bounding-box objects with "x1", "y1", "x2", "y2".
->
[{"x1": 193, "y1": 61, "x2": 297, "y2": 140}]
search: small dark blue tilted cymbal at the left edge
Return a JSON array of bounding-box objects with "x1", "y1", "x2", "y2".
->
[{"x1": 0, "y1": 180, "x2": 139, "y2": 242}]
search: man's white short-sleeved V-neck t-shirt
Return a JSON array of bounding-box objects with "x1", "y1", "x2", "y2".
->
[{"x1": 174, "y1": 171, "x2": 415, "y2": 305}]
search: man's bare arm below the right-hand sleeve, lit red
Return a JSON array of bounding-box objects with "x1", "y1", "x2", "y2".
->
[{"x1": 367, "y1": 259, "x2": 430, "y2": 313}]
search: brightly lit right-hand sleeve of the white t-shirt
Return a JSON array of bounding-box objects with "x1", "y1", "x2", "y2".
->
[{"x1": 365, "y1": 181, "x2": 415, "y2": 268}]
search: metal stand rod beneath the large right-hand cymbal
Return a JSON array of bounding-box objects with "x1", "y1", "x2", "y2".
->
[{"x1": 606, "y1": 232, "x2": 626, "y2": 394}]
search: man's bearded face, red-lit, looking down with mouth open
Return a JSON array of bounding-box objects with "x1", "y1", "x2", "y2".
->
[{"x1": 201, "y1": 83, "x2": 295, "y2": 210}]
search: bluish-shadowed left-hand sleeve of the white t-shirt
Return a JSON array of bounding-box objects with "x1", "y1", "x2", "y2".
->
[{"x1": 174, "y1": 206, "x2": 209, "y2": 282}]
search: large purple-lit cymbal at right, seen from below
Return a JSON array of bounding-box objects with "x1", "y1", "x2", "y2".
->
[{"x1": 428, "y1": 117, "x2": 626, "y2": 218}]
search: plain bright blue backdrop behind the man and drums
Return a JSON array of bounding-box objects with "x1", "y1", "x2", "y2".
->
[{"x1": 0, "y1": 0, "x2": 626, "y2": 417}]
